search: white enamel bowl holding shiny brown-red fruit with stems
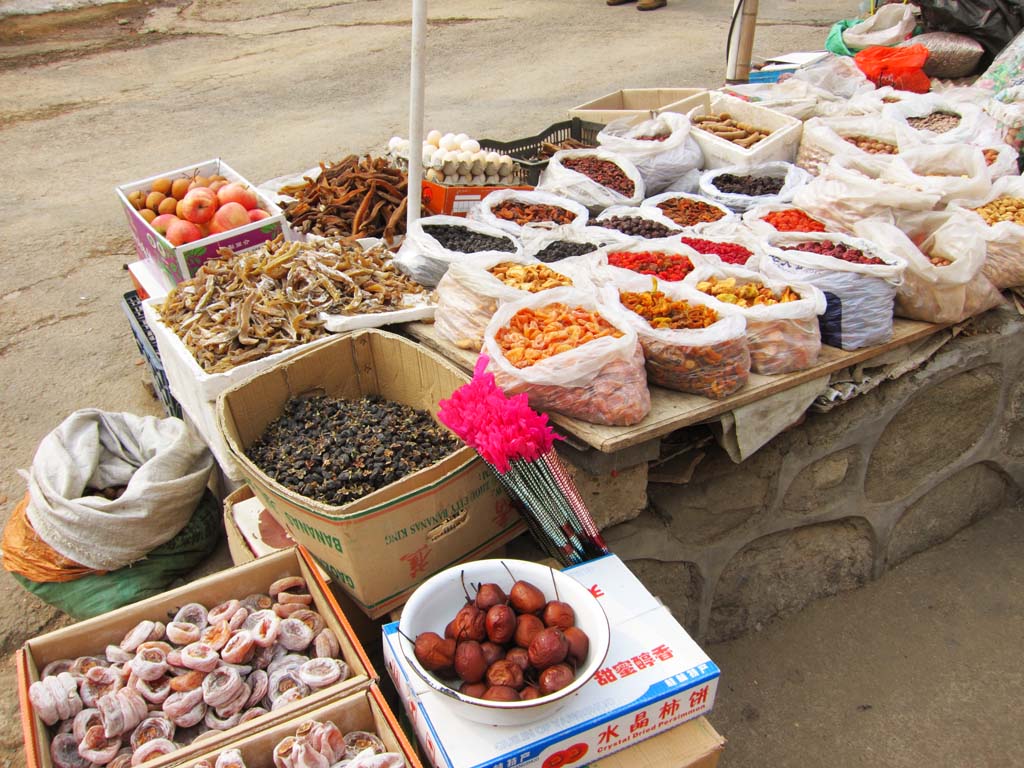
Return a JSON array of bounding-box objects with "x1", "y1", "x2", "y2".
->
[{"x1": 398, "y1": 560, "x2": 610, "y2": 727}]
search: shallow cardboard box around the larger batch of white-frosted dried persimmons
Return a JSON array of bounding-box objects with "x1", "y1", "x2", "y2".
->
[{"x1": 15, "y1": 548, "x2": 378, "y2": 768}]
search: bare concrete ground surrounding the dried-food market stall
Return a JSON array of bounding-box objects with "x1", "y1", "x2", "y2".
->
[{"x1": 0, "y1": 0, "x2": 1024, "y2": 768}]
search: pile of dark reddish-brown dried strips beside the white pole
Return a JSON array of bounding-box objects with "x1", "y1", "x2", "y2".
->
[{"x1": 279, "y1": 155, "x2": 417, "y2": 244}]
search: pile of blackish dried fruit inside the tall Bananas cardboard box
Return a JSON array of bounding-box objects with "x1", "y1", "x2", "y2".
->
[{"x1": 246, "y1": 395, "x2": 460, "y2": 506}]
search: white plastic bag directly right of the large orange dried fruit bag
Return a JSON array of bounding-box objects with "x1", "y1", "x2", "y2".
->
[{"x1": 602, "y1": 274, "x2": 751, "y2": 399}]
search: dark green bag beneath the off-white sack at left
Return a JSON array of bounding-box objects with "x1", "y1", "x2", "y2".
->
[{"x1": 11, "y1": 492, "x2": 223, "y2": 618}]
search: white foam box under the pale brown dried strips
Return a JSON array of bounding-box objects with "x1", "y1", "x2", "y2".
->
[{"x1": 142, "y1": 299, "x2": 333, "y2": 483}]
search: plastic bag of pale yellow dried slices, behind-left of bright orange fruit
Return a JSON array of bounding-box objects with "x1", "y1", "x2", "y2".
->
[{"x1": 434, "y1": 255, "x2": 593, "y2": 350}]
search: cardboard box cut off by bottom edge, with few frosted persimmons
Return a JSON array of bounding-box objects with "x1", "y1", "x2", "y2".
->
[{"x1": 186, "y1": 684, "x2": 423, "y2": 768}]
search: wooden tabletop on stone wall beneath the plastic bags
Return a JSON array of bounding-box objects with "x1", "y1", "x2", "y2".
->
[{"x1": 401, "y1": 317, "x2": 947, "y2": 454}]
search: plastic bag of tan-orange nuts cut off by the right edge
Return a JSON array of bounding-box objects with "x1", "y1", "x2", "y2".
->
[{"x1": 949, "y1": 176, "x2": 1024, "y2": 291}]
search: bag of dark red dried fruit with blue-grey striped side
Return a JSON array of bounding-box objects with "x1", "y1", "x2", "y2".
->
[{"x1": 758, "y1": 232, "x2": 906, "y2": 350}]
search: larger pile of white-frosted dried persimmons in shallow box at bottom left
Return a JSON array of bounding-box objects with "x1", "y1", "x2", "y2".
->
[{"x1": 29, "y1": 577, "x2": 349, "y2": 768}]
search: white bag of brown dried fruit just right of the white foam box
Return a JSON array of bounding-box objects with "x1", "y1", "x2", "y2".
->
[{"x1": 797, "y1": 115, "x2": 920, "y2": 175}]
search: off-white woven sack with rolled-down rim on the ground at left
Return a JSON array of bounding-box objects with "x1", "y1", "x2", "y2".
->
[{"x1": 23, "y1": 409, "x2": 213, "y2": 570}]
